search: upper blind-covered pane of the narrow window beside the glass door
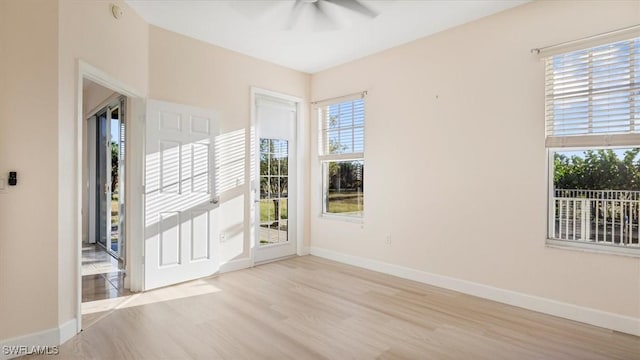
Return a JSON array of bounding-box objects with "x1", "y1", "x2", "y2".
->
[{"x1": 319, "y1": 99, "x2": 365, "y2": 161}]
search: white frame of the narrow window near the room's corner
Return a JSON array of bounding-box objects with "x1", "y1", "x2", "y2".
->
[{"x1": 314, "y1": 92, "x2": 367, "y2": 223}]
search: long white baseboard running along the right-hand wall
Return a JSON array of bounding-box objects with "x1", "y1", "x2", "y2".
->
[{"x1": 311, "y1": 247, "x2": 640, "y2": 336}]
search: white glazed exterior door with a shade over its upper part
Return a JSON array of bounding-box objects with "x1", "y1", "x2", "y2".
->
[{"x1": 254, "y1": 95, "x2": 297, "y2": 262}]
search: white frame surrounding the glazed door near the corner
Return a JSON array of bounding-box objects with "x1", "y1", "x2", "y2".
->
[{"x1": 248, "y1": 86, "x2": 307, "y2": 266}]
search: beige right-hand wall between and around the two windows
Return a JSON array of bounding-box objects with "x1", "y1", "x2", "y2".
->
[{"x1": 311, "y1": 1, "x2": 640, "y2": 318}]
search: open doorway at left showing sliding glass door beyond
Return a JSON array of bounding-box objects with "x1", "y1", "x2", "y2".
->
[{"x1": 81, "y1": 80, "x2": 130, "y2": 317}]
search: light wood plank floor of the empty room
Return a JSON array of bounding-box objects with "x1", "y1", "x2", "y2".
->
[{"x1": 27, "y1": 256, "x2": 640, "y2": 359}]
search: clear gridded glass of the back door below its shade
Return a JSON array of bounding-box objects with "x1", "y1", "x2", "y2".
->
[{"x1": 259, "y1": 138, "x2": 289, "y2": 246}]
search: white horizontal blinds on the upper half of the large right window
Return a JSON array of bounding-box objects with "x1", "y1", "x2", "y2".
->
[{"x1": 546, "y1": 39, "x2": 640, "y2": 147}]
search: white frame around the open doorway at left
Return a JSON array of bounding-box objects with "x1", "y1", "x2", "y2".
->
[{"x1": 75, "y1": 59, "x2": 145, "y2": 332}]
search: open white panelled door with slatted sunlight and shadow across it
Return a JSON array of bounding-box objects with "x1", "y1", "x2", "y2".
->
[{"x1": 144, "y1": 100, "x2": 219, "y2": 290}]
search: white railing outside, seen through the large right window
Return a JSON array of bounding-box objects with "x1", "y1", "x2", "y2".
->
[{"x1": 550, "y1": 189, "x2": 640, "y2": 247}]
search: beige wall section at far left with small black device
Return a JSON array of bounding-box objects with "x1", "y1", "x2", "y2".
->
[{"x1": 0, "y1": 0, "x2": 58, "y2": 339}]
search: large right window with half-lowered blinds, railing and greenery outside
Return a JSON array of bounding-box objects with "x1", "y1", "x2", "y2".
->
[{"x1": 546, "y1": 38, "x2": 640, "y2": 255}]
